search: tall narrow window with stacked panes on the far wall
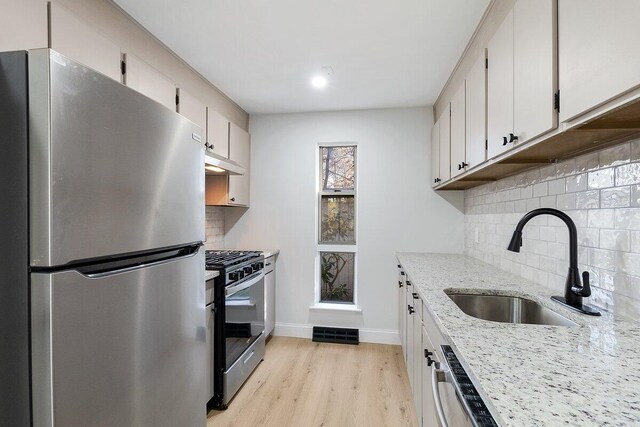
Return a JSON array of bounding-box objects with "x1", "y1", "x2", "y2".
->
[{"x1": 317, "y1": 145, "x2": 357, "y2": 304}]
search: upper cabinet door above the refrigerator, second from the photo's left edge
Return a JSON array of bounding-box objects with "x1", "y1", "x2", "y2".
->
[{"x1": 50, "y1": 2, "x2": 120, "y2": 81}]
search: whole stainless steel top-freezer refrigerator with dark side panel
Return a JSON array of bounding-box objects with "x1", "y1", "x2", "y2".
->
[{"x1": 0, "y1": 49, "x2": 206, "y2": 427}]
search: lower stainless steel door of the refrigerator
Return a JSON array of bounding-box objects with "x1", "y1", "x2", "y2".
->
[{"x1": 31, "y1": 248, "x2": 207, "y2": 427}]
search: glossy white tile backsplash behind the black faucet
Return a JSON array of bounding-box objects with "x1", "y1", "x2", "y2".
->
[{"x1": 465, "y1": 139, "x2": 640, "y2": 320}]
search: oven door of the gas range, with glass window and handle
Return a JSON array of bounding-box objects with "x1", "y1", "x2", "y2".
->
[{"x1": 224, "y1": 271, "x2": 264, "y2": 370}]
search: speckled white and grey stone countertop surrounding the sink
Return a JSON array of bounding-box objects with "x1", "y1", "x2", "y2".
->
[{"x1": 397, "y1": 253, "x2": 640, "y2": 427}]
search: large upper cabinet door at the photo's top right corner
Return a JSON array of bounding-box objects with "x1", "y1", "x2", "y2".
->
[{"x1": 558, "y1": 0, "x2": 640, "y2": 122}]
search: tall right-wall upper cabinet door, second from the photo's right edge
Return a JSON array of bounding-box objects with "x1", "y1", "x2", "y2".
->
[{"x1": 513, "y1": 0, "x2": 558, "y2": 143}]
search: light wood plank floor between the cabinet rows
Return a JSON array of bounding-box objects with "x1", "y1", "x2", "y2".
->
[{"x1": 207, "y1": 337, "x2": 417, "y2": 427}]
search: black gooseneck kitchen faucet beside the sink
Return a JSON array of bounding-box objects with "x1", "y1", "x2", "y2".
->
[{"x1": 507, "y1": 208, "x2": 600, "y2": 316}]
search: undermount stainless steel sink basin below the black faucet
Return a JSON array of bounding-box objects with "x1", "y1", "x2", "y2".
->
[{"x1": 447, "y1": 292, "x2": 578, "y2": 326}]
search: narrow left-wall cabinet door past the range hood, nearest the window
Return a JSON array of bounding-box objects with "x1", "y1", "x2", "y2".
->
[{"x1": 229, "y1": 123, "x2": 251, "y2": 206}]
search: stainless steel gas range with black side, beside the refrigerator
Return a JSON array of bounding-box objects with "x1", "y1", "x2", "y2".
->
[{"x1": 206, "y1": 251, "x2": 265, "y2": 409}]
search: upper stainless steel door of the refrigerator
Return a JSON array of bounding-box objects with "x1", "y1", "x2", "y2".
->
[{"x1": 29, "y1": 49, "x2": 205, "y2": 267}]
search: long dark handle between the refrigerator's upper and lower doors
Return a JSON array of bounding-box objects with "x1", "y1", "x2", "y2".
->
[{"x1": 75, "y1": 244, "x2": 202, "y2": 278}]
